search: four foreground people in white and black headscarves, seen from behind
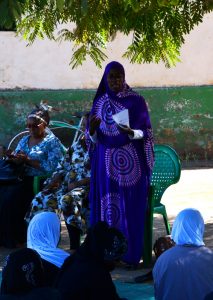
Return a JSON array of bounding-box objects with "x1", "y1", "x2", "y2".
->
[{"x1": 0, "y1": 208, "x2": 213, "y2": 300}]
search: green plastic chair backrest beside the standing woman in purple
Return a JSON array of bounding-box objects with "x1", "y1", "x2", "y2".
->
[{"x1": 151, "y1": 145, "x2": 181, "y2": 206}]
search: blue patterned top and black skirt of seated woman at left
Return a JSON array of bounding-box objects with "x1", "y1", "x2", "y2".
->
[{"x1": 0, "y1": 133, "x2": 63, "y2": 248}]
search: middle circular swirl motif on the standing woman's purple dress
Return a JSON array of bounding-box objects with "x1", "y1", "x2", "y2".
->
[{"x1": 105, "y1": 144, "x2": 141, "y2": 187}]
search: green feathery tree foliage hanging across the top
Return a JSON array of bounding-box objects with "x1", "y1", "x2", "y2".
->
[{"x1": 0, "y1": 0, "x2": 213, "y2": 68}]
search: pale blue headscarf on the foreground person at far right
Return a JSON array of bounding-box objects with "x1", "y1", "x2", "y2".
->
[{"x1": 171, "y1": 208, "x2": 205, "y2": 246}]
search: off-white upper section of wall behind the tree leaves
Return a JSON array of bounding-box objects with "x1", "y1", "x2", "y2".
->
[{"x1": 0, "y1": 13, "x2": 213, "y2": 89}]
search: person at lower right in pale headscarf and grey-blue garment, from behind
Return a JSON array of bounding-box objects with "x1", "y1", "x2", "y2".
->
[{"x1": 153, "y1": 208, "x2": 213, "y2": 300}]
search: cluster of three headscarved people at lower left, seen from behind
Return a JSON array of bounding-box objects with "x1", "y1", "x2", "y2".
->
[{"x1": 0, "y1": 219, "x2": 127, "y2": 300}]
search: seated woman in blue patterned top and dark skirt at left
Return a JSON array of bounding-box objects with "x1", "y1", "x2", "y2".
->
[{"x1": 0, "y1": 106, "x2": 63, "y2": 248}]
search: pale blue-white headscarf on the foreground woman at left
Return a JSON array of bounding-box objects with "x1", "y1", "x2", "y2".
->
[{"x1": 27, "y1": 212, "x2": 70, "y2": 267}]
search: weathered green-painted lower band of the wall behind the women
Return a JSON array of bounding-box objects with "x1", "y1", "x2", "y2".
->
[{"x1": 0, "y1": 86, "x2": 213, "y2": 166}]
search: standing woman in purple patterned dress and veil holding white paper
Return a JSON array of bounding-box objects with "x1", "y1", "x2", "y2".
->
[{"x1": 88, "y1": 61, "x2": 154, "y2": 265}]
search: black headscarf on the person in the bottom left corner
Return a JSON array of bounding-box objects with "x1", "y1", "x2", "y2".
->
[{"x1": 1, "y1": 248, "x2": 44, "y2": 295}]
